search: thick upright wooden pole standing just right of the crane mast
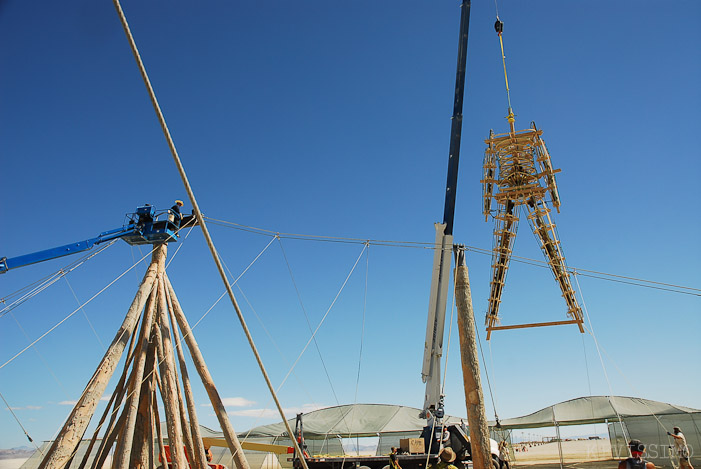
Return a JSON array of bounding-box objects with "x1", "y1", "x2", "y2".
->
[{"x1": 455, "y1": 247, "x2": 492, "y2": 469}]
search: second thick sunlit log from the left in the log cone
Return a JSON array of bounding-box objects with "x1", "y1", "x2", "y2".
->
[{"x1": 112, "y1": 270, "x2": 161, "y2": 469}]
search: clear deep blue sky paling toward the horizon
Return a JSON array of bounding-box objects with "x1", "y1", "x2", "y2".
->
[{"x1": 0, "y1": 0, "x2": 701, "y2": 447}]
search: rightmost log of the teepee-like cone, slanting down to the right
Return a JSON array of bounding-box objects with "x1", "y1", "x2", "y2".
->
[{"x1": 164, "y1": 275, "x2": 250, "y2": 469}]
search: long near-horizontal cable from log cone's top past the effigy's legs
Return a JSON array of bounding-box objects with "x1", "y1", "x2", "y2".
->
[{"x1": 205, "y1": 217, "x2": 701, "y2": 296}]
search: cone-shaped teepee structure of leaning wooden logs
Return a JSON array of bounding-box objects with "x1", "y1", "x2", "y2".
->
[{"x1": 39, "y1": 244, "x2": 249, "y2": 469}]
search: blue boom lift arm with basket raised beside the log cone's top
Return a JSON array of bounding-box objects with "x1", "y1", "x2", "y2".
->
[{"x1": 0, "y1": 205, "x2": 192, "y2": 274}]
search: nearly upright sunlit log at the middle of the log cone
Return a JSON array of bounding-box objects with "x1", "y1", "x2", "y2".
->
[{"x1": 156, "y1": 277, "x2": 187, "y2": 469}]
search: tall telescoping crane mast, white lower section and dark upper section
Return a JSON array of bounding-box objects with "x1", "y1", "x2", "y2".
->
[{"x1": 421, "y1": 0, "x2": 470, "y2": 418}]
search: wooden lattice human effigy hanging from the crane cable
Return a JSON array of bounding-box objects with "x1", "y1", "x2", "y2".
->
[{"x1": 482, "y1": 119, "x2": 584, "y2": 340}]
